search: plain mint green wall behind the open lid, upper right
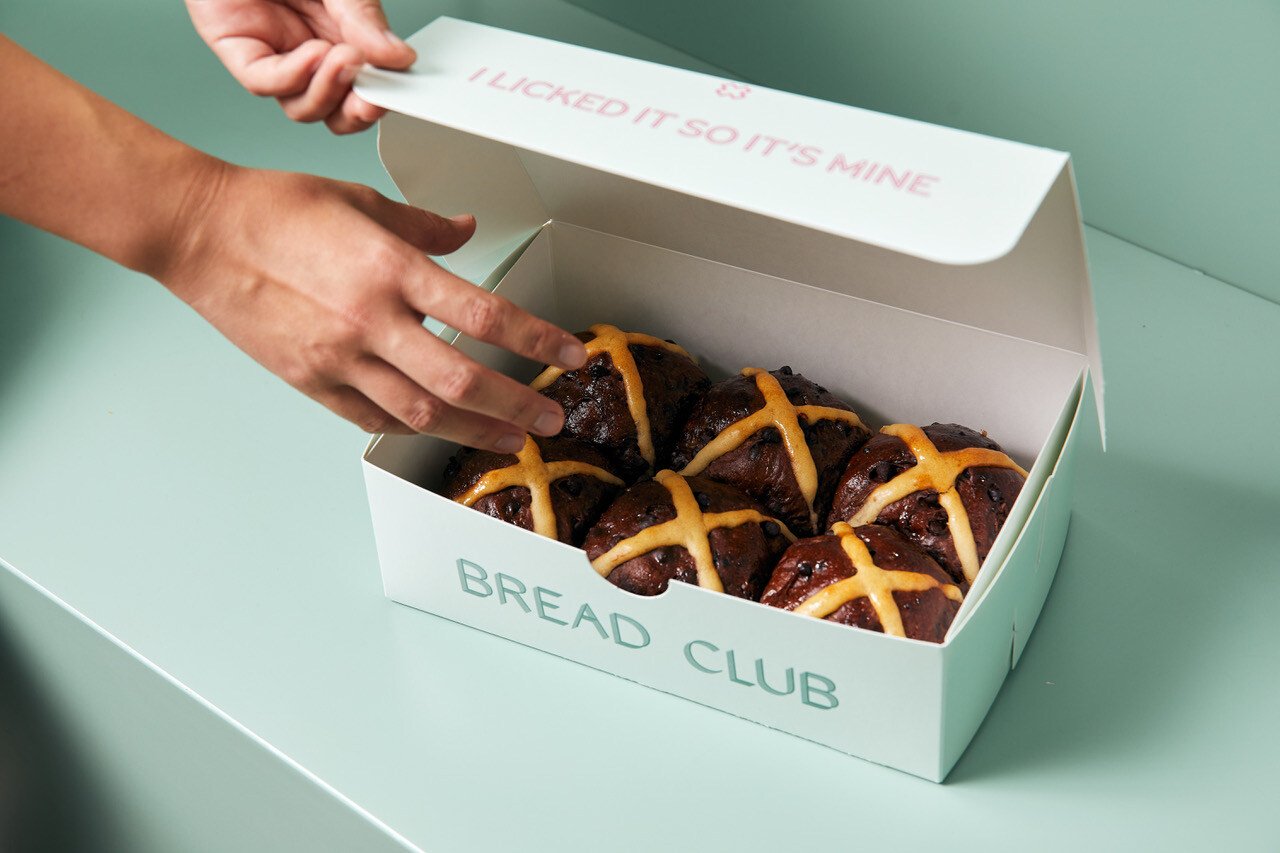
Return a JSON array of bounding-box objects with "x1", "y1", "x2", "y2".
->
[{"x1": 572, "y1": 0, "x2": 1280, "y2": 301}]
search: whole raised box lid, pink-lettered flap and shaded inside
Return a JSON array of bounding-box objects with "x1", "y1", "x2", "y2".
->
[{"x1": 356, "y1": 18, "x2": 1102, "y2": 422}]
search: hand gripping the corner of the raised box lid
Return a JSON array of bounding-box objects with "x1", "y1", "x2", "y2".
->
[{"x1": 187, "y1": 0, "x2": 417, "y2": 133}]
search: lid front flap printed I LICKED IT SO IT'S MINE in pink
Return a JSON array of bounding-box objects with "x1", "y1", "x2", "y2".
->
[{"x1": 357, "y1": 18, "x2": 1066, "y2": 258}]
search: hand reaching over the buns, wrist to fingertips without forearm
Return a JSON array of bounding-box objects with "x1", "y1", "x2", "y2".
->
[{"x1": 161, "y1": 161, "x2": 586, "y2": 452}]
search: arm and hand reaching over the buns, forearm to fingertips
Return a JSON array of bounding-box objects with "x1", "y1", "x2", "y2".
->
[{"x1": 0, "y1": 36, "x2": 586, "y2": 452}]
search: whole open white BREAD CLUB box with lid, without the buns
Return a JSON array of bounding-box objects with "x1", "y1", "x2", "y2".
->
[{"x1": 357, "y1": 18, "x2": 1101, "y2": 781}]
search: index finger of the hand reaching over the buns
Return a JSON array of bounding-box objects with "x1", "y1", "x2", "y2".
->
[{"x1": 404, "y1": 257, "x2": 586, "y2": 370}]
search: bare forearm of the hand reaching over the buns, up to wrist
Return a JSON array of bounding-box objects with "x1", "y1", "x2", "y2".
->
[{"x1": 0, "y1": 36, "x2": 225, "y2": 277}]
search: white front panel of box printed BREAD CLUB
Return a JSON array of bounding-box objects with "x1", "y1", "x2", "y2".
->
[{"x1": 366, "y1": 464, "x2": 942, "y2": 779}]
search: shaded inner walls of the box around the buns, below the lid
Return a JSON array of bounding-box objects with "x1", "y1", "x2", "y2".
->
[{"x1": 367, "y1": 222, "x2": 1085, "y2": 635}]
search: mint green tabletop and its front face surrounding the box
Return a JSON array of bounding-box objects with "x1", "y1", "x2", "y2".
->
[{"x1": 0, "y1": 0, "x2": 1280, "y2": 850}]
